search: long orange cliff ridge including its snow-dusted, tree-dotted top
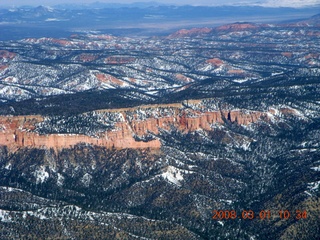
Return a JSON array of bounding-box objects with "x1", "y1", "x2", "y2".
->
[{"x1": 0, "y1": 100, "x2": 300, "y2": 149}]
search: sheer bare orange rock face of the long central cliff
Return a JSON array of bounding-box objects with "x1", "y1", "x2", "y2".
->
[{"x1": 0, "y1": 104, "x2": 267, "y2": 149}]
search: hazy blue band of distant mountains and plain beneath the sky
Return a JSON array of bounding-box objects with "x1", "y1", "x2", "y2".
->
[{"x1": 0, "y1": 3, "x2": 320, "y2": 40}]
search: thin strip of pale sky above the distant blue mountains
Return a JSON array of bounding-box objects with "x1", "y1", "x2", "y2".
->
[{"x1": 0, "y1": 0, "x2": 320, "y2": 7}]
